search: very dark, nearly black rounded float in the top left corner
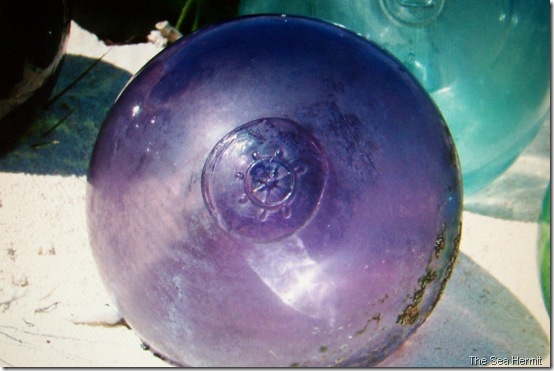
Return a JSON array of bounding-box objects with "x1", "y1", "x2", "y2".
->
[{"x1": 0, "y1": 0, "x2": 71, "y2": 155}]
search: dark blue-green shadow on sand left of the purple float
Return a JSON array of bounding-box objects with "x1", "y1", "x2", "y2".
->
[{"x1": 0, "y1": 55, "x2": 131, "y2": 176}]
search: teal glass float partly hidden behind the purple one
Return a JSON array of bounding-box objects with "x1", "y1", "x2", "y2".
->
[{"x1": 239, "y1": 0, "x2": 551, "y2": 195}]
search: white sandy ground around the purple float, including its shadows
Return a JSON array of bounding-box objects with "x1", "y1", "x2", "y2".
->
[{"x1": 0, "y1": 23, "x2": 550, "y2": 367}]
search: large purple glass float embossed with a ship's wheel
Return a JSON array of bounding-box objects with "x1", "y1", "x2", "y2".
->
[{"x1": 87, "y1": 16, "x2": 462, "y2": 367}]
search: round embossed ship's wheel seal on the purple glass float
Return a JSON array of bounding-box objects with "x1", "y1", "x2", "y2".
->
[{"x1": 202, "y1": 118, "x2": 328, "y2": 242}]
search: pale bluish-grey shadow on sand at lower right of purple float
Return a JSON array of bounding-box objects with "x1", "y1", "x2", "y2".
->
[{"x1": 379, "y1": 253, "x2": 550, "y2": 367}]
